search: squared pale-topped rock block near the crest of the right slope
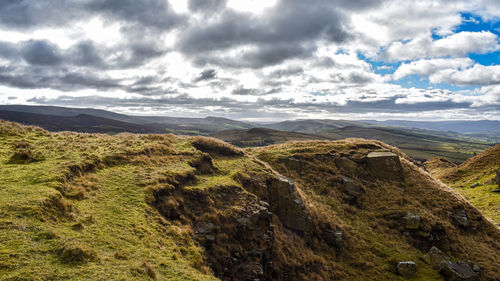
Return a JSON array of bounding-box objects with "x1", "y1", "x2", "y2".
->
[{"x1": 366, "y1": 151, "x2": 404, "y2": 181}]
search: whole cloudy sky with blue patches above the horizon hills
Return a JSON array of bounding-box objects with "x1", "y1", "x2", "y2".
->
[{"x1": 0, "y1": 0, "x2": 500, "y2": 121}]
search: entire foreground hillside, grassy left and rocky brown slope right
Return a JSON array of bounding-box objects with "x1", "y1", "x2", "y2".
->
[{"x1": 0, "y1": 121, "x2": 500, "y2": 280}]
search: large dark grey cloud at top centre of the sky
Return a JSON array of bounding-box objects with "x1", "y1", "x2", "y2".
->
[{"x1": 176, "y1": 0, "x2": 349, "y2": 68}]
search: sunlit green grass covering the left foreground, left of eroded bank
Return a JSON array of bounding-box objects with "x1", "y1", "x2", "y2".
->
[{"x1": 0, "y1": 123, "x2": 215, "y2": 280}]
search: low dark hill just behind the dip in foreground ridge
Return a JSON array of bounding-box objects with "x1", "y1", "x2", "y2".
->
[{"x1": 211, "y1": 128, "x2": 328, "y2": 147}]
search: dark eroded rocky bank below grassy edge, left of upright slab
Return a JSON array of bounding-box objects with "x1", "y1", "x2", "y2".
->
[{"x1": 154, "y1": 186, "x2": 275, "y2": 280}]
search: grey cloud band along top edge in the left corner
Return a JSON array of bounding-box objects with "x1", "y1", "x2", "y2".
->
[{"x1": 0, "y1": 0, "x2": 183, "y2": 30}]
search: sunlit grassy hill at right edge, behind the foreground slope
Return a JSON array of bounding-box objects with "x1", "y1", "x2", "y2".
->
[{"x1": 426, "y1": 144, "x2": 500, "y2": 223}]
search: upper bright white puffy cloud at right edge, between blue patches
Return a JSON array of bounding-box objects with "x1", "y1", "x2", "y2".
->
[{"x1": 382, "y1": 31, "x2": 500, "y2": 61}]
